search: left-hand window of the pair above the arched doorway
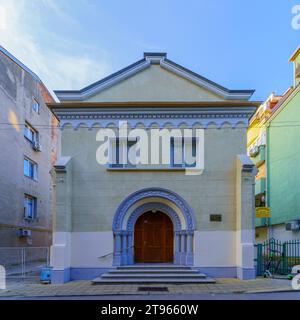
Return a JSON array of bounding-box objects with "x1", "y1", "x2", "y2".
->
[{"x1": 110, "y1": 138, "x2": 136, "y2": 168}]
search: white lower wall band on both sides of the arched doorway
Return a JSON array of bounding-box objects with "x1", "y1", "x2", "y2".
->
[{"x1": 51, "y1": 231, "x2": 253, "y2": 270}]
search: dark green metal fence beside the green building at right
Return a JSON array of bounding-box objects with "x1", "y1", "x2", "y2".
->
[{"x1": 255, "y1": 238, "x2": 300, "y2": 276}]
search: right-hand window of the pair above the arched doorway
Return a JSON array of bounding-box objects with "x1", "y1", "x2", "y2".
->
[{"x1": 170, "y1": 137, "x2": 197, "y2": 168}]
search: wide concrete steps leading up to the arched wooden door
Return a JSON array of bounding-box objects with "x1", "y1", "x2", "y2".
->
[{"x1": 92, "y1": 265, "x2": 215, "y2": 284}]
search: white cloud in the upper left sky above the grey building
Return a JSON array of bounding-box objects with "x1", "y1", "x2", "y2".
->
[{"x1": 0, "y1": 0, "x2": 111, "y2": 90}]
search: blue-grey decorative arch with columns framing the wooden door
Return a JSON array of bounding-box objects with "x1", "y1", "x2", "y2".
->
[{"x1": 112, "y1": 188, "x2": 196, "y2": 265}]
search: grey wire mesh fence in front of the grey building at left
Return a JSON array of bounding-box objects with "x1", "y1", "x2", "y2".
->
[{"x1": 0, "y1": 247, "x2": 50, "y2": 278}]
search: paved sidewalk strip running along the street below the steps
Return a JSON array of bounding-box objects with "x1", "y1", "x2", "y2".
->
[{"x1": 0, "y1": 278, "x2": 293, "y2": 298}]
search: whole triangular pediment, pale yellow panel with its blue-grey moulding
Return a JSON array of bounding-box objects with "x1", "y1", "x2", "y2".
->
[{"x1": 55, "y1": 53, "x2": 253, "y2": 102}]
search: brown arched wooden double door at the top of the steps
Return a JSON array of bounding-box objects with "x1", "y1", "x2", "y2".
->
[{"x1": 134, "y1": 211, "x2": 174, "y2": 263}]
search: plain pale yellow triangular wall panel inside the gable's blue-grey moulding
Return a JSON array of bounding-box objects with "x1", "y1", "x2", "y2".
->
[{"x1": 86, "y1": 65, "x2": 222, "y2": 102}]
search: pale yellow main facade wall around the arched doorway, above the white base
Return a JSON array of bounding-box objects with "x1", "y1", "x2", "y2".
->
[{"x1": 55, "y1": 127, "x2": 246, "y2": 232}]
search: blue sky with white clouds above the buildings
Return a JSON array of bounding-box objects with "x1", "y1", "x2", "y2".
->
[{"x1": 0, "y1": 0, "x2": 300, "y2": 100}]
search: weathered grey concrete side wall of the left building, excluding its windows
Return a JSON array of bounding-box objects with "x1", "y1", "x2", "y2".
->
[{"x1": 0, "y1": 53, "x2": 59, "y2": 247}]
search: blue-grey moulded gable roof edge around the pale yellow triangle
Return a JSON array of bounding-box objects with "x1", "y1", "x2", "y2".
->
[{"x1": 54, "y1": 52, "x2": 254, "y2": 101}]
